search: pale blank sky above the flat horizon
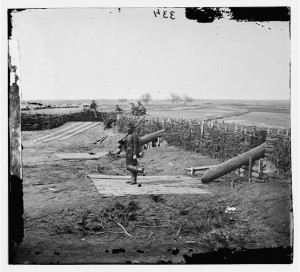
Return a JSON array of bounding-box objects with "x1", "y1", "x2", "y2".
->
[{"x1": 12, "y1": 8, "x2": 290, "y2": 100}]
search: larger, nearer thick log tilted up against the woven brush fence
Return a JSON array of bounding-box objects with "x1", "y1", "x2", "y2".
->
[{"x1": 201, "y1": 143, "x2": 266, "y2": 182}]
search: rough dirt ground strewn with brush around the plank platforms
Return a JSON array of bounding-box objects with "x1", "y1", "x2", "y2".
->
[{"x1": 13, "y1": 123, "x2": 292, "y2": 264}]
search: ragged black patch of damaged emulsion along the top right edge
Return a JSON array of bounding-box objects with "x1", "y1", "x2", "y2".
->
[{"x1": 185, "y1": 7, "x2": 290, "y2": 23}]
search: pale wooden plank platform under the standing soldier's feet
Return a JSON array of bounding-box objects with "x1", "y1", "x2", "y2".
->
[{"x1": 88, "y1": 175, "x2": 211, "y2": 197}]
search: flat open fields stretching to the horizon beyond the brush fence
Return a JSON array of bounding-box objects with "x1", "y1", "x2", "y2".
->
[{"x1": 22, "y1": 100, "x2": 291, "y2": 128}]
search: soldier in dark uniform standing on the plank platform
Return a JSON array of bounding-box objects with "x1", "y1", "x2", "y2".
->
[{"x1": 125, "y1": 123, "x2": 144, "y2": 185}]
